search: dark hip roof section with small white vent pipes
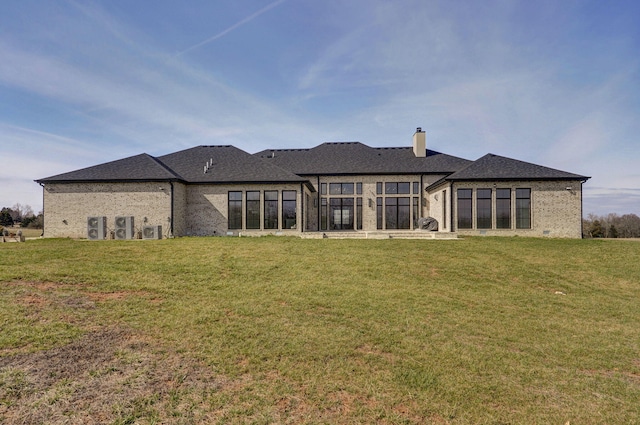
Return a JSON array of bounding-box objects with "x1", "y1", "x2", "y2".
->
[{"x1": 158, "y1": 146, "x2": 307, "y2": 183}]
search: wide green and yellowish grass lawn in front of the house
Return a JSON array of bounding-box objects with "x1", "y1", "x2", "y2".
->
[{"x1": 0, "y1": 237, "x2": 640, "y2": 424}]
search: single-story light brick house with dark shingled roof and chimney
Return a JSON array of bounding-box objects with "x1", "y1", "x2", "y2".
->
[{"x1": 36, "y1": 128, "x2": 589, "y2": 239}]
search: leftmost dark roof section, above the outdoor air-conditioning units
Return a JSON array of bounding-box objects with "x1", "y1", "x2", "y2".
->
[{"x1": 36, "y1": 153, "x2": 178, "y2": 183}]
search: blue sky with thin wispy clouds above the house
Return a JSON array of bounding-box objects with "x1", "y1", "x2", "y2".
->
[{"x1": 0, "y1": 0, "x2": 640, "y2": 215}]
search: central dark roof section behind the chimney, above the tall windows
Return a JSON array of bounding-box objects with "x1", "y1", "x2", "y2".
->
[{"x1": 255, "y1": 142, "x2": 471, "y2": 175}]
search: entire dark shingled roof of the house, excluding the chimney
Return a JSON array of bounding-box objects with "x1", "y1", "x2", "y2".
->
[{"x1": 36, "y1": 142, "x2": 589, "y2": 188}]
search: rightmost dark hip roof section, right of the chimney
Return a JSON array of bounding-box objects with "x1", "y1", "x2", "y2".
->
[{"x1": 445, "y1": 154, "x2": 589, "y2": 181}]
